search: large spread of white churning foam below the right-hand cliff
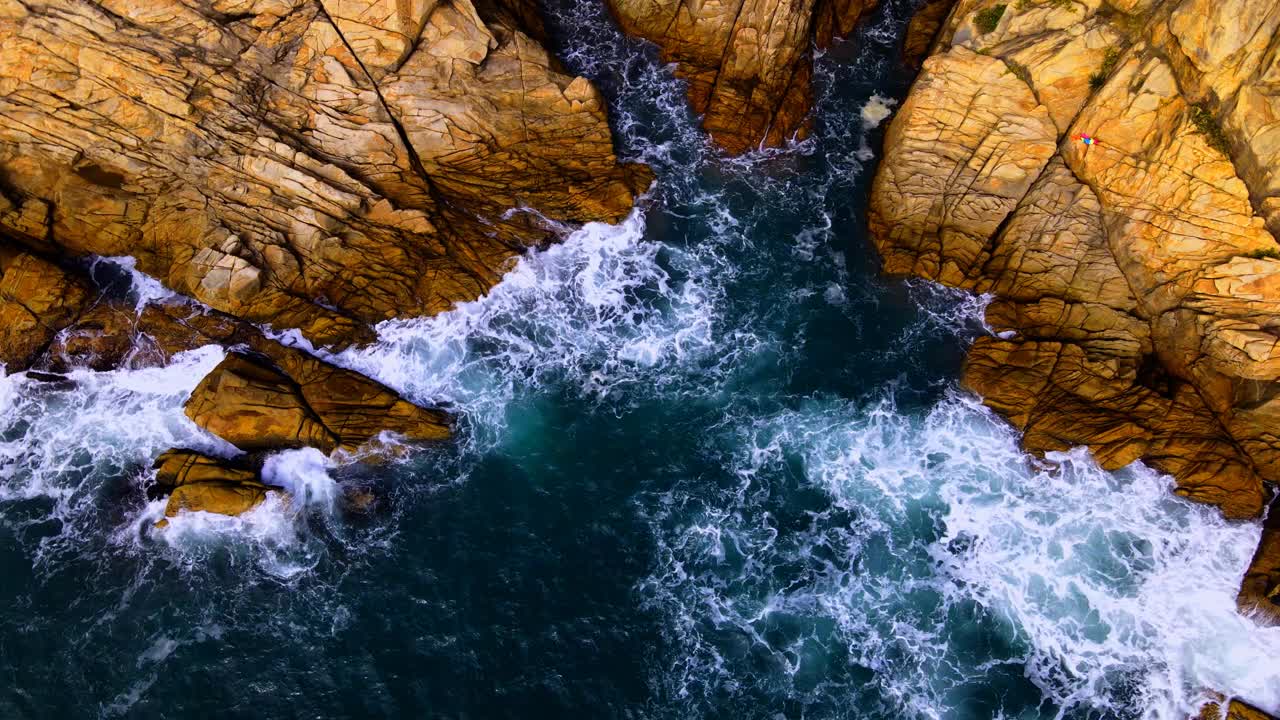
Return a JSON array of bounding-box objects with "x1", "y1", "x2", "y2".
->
[{"x1": 641, "y1": 395, "x2": 1280, "y2": 720}]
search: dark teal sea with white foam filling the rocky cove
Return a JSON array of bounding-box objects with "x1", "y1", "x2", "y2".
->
[{"x1": 0, "y1": 0, "x2": 1280, "y2": 719}]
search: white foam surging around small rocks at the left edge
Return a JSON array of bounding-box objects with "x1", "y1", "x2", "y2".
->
[{"x1": 0, "y1": 338, "x2": 348, "y2": 577}]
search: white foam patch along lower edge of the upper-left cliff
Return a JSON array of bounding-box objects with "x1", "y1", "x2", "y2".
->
[{"x1": 333, "y1": 209, "x2": 732, "y2": 443}]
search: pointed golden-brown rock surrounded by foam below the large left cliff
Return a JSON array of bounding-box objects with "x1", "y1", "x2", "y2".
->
[{"x1": 186, "y1": 341, "x2": 449, "y2": 452}]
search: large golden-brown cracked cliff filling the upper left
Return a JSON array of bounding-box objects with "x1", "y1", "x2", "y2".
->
[{"x1": 0, "y1": 0, "x2": 649, "y2": 343}]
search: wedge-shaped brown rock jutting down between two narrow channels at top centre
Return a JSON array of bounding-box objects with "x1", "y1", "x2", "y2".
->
[{"x1": 608, "y1": 0, "x2": 877, "y2": 154}]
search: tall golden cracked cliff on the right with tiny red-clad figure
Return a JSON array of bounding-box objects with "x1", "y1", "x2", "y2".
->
[{"x1": 870, "y1": 0, "x2": 1280, "y2": 518}]
